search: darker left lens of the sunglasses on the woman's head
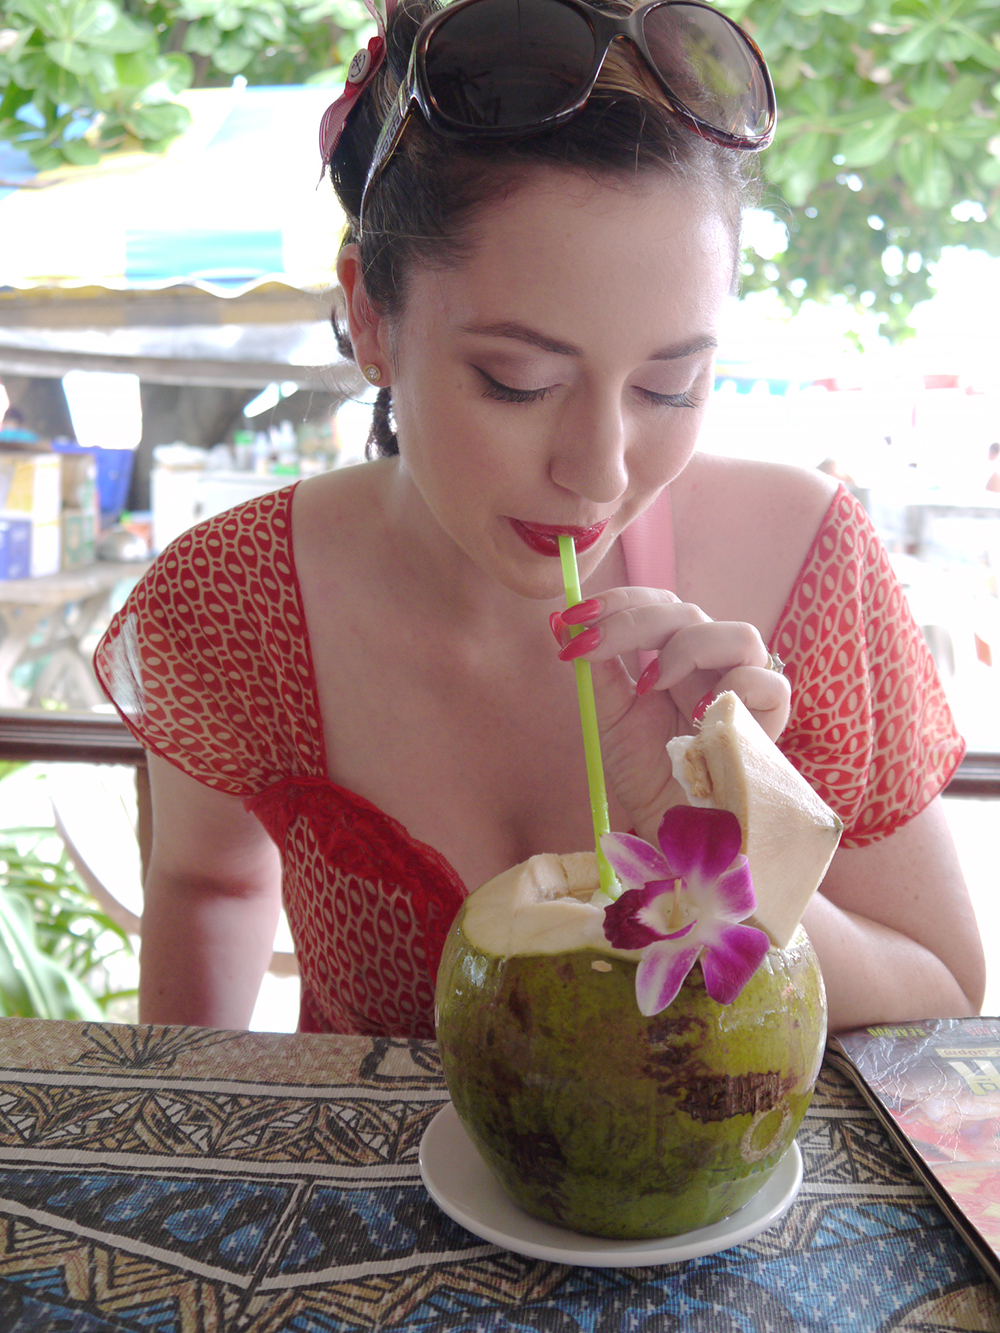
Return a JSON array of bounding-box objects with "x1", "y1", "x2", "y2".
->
[{"x1": 425, "y1": 0, "x2": 595, "y2": 129}]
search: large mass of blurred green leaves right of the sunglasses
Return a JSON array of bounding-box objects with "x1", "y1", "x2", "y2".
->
[{"x1": 719, "y1": 0, "x2": 1000, "y2": 337}]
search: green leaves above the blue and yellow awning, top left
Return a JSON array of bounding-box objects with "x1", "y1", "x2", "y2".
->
[{"x1": 0, "y1": 0, "x2": 375, "y2": 163}]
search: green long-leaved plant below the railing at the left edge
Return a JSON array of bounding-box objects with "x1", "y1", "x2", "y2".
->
[{"x1": 0, "y1": 764, "x2": 135, "y2": 1020}]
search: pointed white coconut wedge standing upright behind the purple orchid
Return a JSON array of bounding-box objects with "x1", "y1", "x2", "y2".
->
[{"x1": 667, "y1": 690, "x2": 844, "y2": 948}]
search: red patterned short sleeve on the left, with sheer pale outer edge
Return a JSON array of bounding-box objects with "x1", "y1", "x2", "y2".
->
[{"x1": 95, "y1": 488, "x2": 325, "y2": 798}]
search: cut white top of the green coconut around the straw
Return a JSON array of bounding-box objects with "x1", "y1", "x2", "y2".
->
[{"x1": 461, "y1": 852, "x2": 639, "y2": 958}]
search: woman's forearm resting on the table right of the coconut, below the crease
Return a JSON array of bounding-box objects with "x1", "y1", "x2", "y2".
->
[{"x1": 803, "y1": 893, "x2": 979, "y2": 1032}]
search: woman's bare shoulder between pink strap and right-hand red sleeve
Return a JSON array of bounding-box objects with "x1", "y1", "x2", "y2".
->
[{"x1": 671, "y1": 455, "x2": 837, "y2": 637}]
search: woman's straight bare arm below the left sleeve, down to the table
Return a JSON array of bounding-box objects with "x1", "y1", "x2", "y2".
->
[{"x1": 139, "y1": 754, "x2": 281, "y2": 1028}]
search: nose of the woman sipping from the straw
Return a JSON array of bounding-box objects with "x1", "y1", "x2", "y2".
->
[{"x1": 549, "y1": 395, "x2": 628, "y2": 505}]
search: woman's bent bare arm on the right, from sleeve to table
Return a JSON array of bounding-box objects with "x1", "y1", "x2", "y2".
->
[{"x1": 803, "y1": 797, "x2": 985, "y2": 1032}]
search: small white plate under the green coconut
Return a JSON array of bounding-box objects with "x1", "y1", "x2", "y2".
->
[{"x1": 420, "y1": 1102, "x2": 803, "y2": 1268}]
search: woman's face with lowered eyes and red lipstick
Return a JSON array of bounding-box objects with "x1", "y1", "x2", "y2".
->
[{"x1": 380, "y1": 168, "x2": 733, "y2": 597}]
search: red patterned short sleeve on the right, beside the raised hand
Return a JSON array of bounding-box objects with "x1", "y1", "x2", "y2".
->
[{"x1": 771, "y1": 487, "x2": 965, "y2": 846}]
